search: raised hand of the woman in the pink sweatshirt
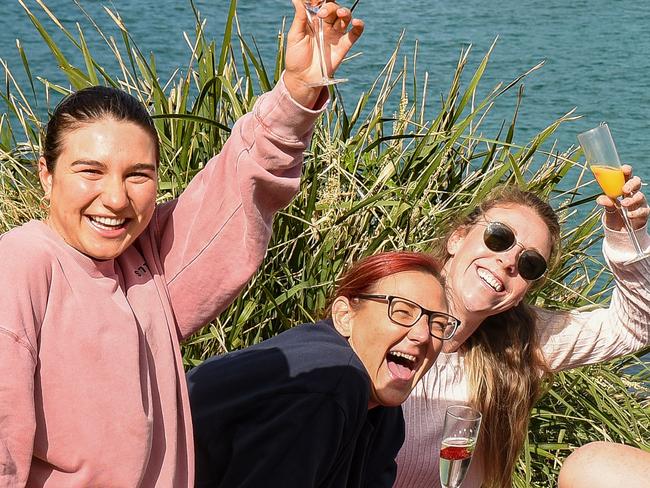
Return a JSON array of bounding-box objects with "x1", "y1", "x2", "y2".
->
[{"x1": 284, "y1": 0, "x2": 364, "y2": 107}]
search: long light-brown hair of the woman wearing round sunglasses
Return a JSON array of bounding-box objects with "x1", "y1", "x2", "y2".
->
[{"x1": 434, "y1": 186, "x2": 560, "y2": 488}]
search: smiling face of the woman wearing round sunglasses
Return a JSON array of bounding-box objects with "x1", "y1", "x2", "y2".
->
[{"x1": 445, "y1": 205, "x2": 551, "y2": 322}]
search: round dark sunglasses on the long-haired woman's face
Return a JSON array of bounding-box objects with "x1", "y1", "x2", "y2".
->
[{"x1": 476, "y1": 221, "x2": 548, "y2": 281}]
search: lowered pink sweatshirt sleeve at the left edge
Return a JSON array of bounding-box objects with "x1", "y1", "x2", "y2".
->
[{"x1": 0, "y1": 233, "x2": 49, "y2": 488}]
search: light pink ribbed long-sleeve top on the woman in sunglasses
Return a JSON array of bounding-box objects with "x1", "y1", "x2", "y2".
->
[{"x1": 394, "y1": 228, "x2": 650, "y2": 488}]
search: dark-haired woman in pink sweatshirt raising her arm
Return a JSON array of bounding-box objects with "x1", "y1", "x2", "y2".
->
[{"x1": 0, "y1": 0, "x2": 363, "y2": 488}]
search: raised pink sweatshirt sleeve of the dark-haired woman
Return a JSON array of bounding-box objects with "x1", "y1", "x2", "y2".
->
[{"x1": 151, "y1": 76, "x2": 327, "y2": 337}]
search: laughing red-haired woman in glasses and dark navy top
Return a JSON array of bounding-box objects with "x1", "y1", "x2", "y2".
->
[{"x1": 187, "y1": 252, "x2": 458, "y2": 488}]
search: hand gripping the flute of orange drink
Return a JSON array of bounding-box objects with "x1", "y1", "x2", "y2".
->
[{"x1": 596, "y1": 164, "x2": 650, "y2": 230}]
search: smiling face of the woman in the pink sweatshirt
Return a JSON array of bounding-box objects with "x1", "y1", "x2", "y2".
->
[{"x1": 39, "y1": 118, "x2": 157, "y2": 259}]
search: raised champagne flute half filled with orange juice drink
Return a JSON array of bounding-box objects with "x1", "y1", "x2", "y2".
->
[{"x1": 578, "y1": 122, "x2": 649, "y2": 264}]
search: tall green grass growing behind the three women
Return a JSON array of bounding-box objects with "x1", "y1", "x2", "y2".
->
[{"x1": 0, "y1": 0, "x2": 650, "y2": 487}]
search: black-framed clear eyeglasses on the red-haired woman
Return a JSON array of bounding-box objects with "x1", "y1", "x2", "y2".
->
[{"x1": 355, "y1": 294, "x2": 460, "y2": 341}]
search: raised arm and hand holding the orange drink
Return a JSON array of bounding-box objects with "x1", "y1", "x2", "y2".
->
[{"x1": 537, "y1": 166, "x2": 650, "y2": 371}]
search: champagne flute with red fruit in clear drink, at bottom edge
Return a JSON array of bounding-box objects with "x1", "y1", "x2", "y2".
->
[{"x1": 440, "y1": 405, "x2": 481, "y2": 488}]
